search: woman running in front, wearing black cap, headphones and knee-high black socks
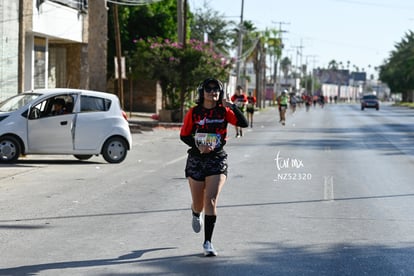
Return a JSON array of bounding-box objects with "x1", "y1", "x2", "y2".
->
[{"x1": 180, "y1": 78, "x2": 248, "y2": 256}]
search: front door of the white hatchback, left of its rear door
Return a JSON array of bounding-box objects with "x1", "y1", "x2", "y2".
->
[{"x1": 27, "y1": 96, "x2": 75, "y2": 154}]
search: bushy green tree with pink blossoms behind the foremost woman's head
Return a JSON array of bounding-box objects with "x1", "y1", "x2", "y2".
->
[{"x1": 133, "y1": 38, "x2": 233, "y2": 117}]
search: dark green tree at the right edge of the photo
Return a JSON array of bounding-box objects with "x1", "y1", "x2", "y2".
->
[{"x1": 379, "y1": 31, "x2": 414, "y2": 101}]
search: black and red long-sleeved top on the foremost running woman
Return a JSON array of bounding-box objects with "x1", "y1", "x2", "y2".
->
[{"x1": 180, "y1": 105, "x2": 248, "y2": 155}]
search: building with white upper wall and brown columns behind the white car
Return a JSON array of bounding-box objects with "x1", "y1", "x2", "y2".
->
[{"x1": 0, "y1": 0, "x2": 108, "y2": 101}]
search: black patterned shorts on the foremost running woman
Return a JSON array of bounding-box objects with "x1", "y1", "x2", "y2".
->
[{"x1": 185, "y1": 151, "x2": 227, "y2": 181}]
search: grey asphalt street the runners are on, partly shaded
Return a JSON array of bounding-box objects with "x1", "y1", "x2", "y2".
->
[{"x1": 0, "y1": 104, "x2": 414, "y2": 275}]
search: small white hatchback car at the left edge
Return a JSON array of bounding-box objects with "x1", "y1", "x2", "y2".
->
[{"x1": 0, "y1": 88, "x2": 132, "y2": 163}]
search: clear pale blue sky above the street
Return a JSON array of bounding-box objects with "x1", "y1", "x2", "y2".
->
[{"x1": 188, "y1": 0, "x2": 414, "y2": 75}]
